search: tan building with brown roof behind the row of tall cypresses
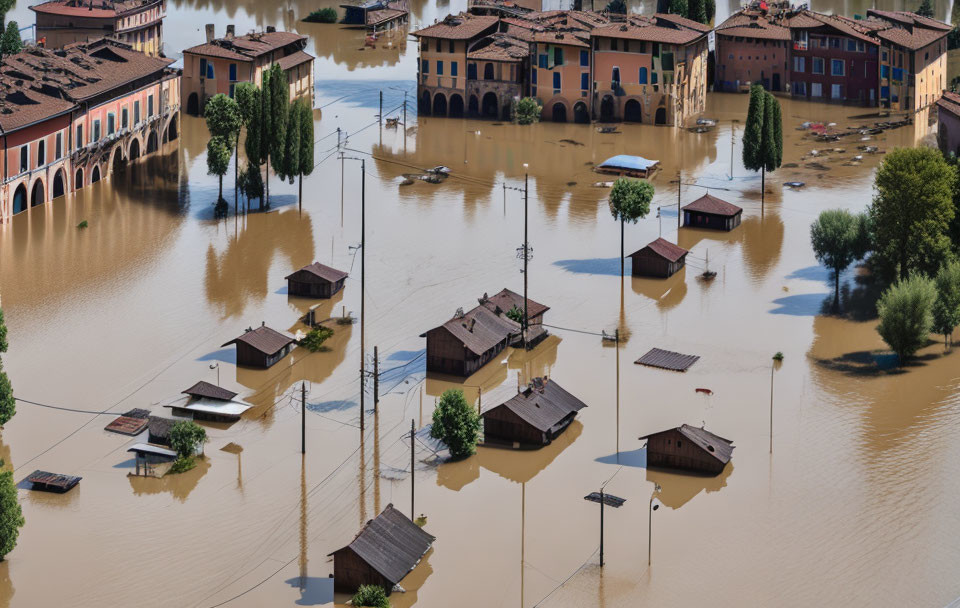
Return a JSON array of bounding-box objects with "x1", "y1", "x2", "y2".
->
[{"x1": 183, "y1": 25, "x2": 314, "y2": 116}]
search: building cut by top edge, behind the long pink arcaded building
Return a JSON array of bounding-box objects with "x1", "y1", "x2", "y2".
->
[{"x1": 30, "y1": 0, "x2": 166, "y2": 57}]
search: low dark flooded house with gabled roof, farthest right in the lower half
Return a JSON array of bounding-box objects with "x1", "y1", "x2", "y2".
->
[{"x1": 640, "y1": 424, "x2": 734, "y2": 475}]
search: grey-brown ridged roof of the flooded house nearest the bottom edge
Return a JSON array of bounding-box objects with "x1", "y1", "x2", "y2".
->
[{"x1": 330, "y1": 503, "x2": 436, "y2": 585}]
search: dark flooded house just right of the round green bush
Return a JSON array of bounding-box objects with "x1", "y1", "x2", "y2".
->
[{"x1": 483, "y1": 377, "x2": 587, "y2": 447}]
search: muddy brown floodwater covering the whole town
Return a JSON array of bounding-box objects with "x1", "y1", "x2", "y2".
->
[{"x1": 0, "y1": 2, "x2": 960, "y2": 608}]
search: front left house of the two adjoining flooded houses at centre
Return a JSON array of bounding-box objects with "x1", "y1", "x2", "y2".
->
[{"x1": 420, "y1": 305, "x2": 520, "y2": 377}]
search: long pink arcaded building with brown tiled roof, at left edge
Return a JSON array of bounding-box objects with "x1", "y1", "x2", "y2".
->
[{"x1": 0, "y1": 39, "x2": 180, "y2": 226}]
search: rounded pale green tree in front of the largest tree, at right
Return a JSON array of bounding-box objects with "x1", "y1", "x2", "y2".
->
[{"x1": 877, "y1": 274, "x2": 937, "y2": 365}]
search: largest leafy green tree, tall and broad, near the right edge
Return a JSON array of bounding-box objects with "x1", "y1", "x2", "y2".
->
[{"x1": 869, "y1": 148, "x2": 957, "y2": 280}]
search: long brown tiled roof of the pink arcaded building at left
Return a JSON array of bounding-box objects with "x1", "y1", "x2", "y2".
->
[{"x1": 0, "y1": 39, "x2": 173, "y2": 132}]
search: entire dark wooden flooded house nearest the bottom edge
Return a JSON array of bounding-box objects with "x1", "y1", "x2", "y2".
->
[{"x1": 330, "y1": 504, "x2": 435, "y2": 594}]
